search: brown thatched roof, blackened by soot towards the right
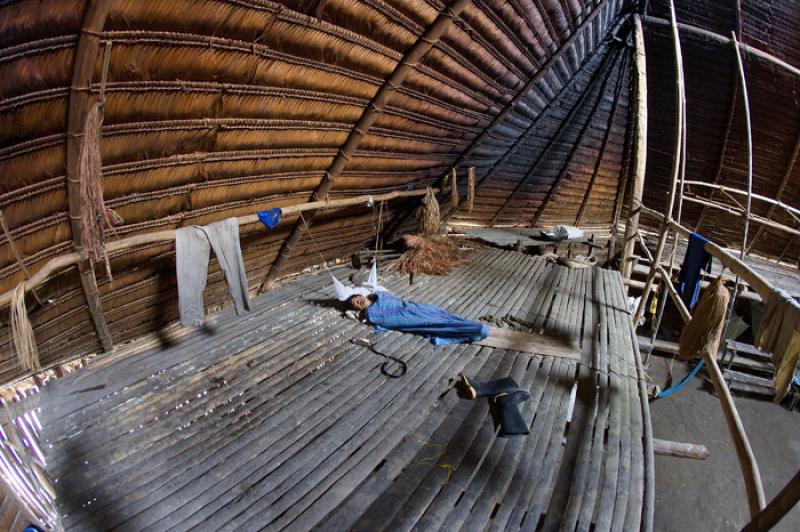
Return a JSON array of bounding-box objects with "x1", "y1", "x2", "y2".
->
[{"x1": 0, "y1": 0, "x2": 800, "y2": 380}]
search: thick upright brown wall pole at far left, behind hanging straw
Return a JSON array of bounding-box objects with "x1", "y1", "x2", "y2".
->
[{"x1": 66, "y1": 0, "x2": 114, "y2": 351}]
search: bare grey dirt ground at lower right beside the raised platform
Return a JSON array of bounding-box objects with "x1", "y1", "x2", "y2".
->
[{"x1": 648, "y1": 356, "x2": 800, "y2": 532}]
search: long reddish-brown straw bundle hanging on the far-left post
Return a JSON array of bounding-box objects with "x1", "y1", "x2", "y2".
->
[{"x1": 78, "y1": 102, "x2": 111, "y2": 279}]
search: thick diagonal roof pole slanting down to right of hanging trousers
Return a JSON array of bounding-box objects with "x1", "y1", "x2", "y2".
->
[{"x1": 258, "y1": 0, "x2": 476, "y2": 293}]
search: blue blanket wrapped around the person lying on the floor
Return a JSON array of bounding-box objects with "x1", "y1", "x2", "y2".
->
[{"x1": 366, "y1": 291, "x2": 489, "y2": 345}]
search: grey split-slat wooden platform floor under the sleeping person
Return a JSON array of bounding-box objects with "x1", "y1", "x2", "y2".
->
[{"x1": 41, "y1": 250, "x2": 654, "y2": 531}]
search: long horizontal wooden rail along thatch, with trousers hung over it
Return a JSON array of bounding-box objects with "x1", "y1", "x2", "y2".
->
[{"x1": 0, "y1": 189, "x2": 439, "y2": 307}]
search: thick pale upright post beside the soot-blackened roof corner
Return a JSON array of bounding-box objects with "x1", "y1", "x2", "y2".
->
[{"x1": 621, "y1": 15, "x2": 647, "y2": 282}]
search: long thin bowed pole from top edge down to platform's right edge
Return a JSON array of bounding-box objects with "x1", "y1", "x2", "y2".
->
[{"x1": 633, "y1": 0, "x2": 685, "y2": 324}]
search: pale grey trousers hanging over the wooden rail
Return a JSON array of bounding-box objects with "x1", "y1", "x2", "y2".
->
[{"x1": 175, "y1": 218, "x2": 250, "y2": 327}]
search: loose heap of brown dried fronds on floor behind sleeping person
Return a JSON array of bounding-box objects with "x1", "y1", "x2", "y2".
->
[{"x1": 397, "y1": 235, "x2": 467, "y2": 275}]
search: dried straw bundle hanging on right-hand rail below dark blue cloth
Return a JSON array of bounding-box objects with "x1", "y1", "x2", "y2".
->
[{"x1": 680, "y1": 275, "x2": 731, "y2": 360}]
